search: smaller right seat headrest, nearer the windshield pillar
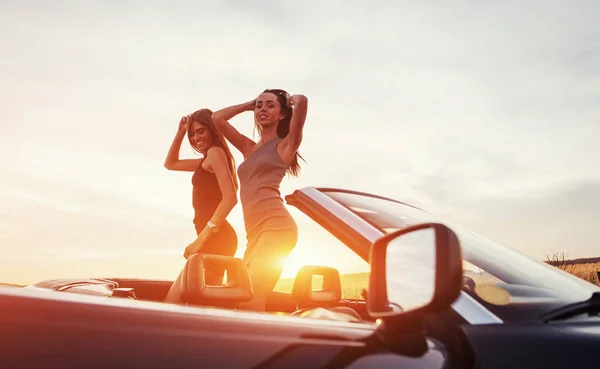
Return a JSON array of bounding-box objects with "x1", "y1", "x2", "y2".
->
[{"x1": 292, "y1": 265, "x2": 342, "y2": 307}]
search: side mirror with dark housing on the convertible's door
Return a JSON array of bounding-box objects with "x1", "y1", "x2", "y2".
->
[{"x1": 367, "y1": 223, "x2": 462, "y2": 320}]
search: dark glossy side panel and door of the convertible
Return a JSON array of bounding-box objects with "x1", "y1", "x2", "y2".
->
[{"x1": 0, "y1": 288, "x2": 454, "y2": 369}]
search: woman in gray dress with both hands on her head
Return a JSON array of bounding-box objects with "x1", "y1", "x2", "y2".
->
[{"x1": 212, "y1": 89, "x2": 308, "y2": 311}]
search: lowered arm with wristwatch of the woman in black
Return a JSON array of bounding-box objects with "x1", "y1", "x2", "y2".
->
[{"x1": 184, "y1": 146, "x2": 237, "y2": 258}]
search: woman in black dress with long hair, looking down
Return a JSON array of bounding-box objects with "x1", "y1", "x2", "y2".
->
[{"x1": 165, "y1": 109, "x2": 238, "y2": 302}]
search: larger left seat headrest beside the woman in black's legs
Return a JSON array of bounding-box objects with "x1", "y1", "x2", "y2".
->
[{"x1": 180, "y1": 254, "x2": 253, "y2": 305}]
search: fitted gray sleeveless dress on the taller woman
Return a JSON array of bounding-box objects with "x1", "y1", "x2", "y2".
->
[{"x1": 238, "y1": 138, "x2": 298, "y2": 268}]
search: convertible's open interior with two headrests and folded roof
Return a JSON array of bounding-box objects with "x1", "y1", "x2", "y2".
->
[{"x1": 34, "y1": 254, "x2": 375, "y2": 322}]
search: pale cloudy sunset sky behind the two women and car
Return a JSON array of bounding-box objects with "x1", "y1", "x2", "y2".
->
[{"x1": 0, "y1": 0, "x2": 600, "y2": 283}]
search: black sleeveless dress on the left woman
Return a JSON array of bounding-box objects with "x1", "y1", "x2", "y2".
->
[{"x1": 192, "y1": 163, "x2": 238, "y2": 256}]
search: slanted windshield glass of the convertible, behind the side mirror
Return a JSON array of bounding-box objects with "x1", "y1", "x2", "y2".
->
[{"x1": 318, "y1": 188, "x2": 600, "y2": 314}]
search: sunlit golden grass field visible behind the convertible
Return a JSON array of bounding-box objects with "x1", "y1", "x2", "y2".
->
[{"x1": 275, "y1": 262, "x2": 600, "y2": 299}]
